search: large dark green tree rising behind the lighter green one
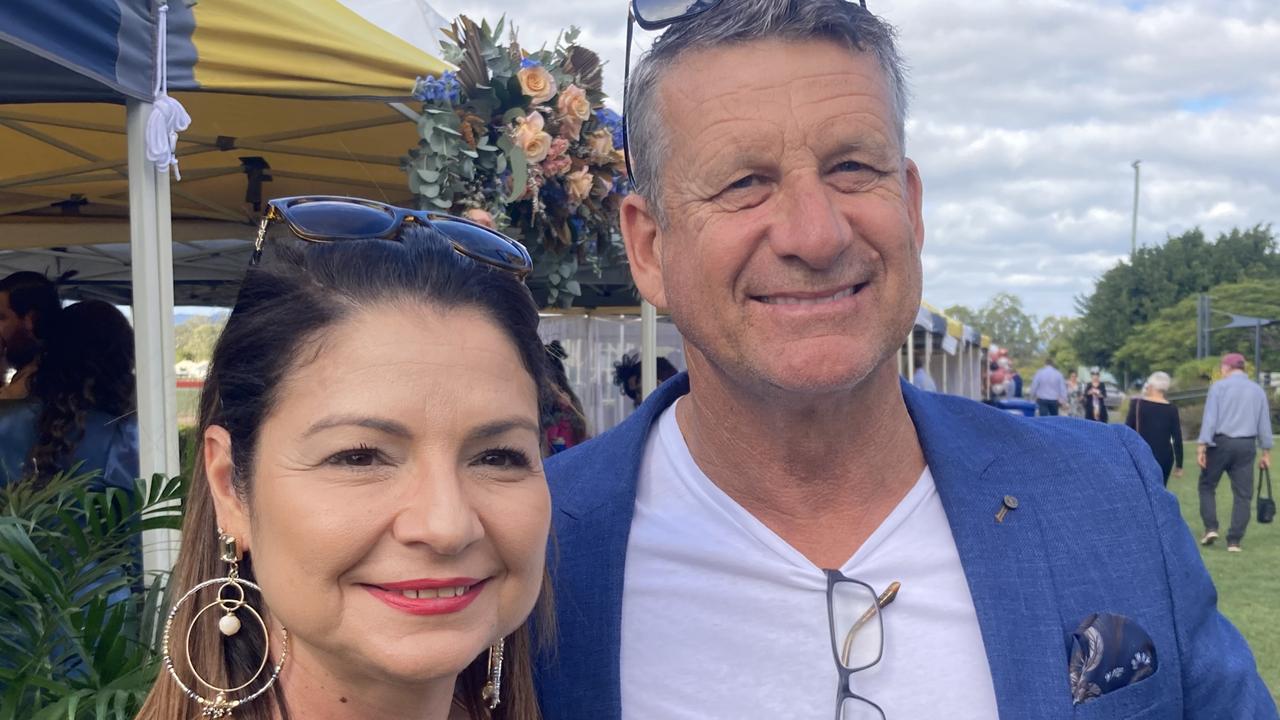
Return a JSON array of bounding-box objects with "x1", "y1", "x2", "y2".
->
[{"x1": 1073, "y1": 225, "x2": 1280, "y2": 370}]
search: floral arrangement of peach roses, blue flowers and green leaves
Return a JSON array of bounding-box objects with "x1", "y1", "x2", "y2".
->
[{"x1": 406, "y1": 17, "x2": 627, "y2": 306}]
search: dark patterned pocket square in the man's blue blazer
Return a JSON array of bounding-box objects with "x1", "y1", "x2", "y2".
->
[{"x1": 1068, "y1": 612, "x2": 1156, "y2": 705}]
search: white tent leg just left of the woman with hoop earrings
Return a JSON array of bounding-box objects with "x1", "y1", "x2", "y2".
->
[{"x1": 125, "y1": 100, "x2": 179, "y2": 574}]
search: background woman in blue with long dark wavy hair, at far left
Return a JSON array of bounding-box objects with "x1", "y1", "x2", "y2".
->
[{"x1": 0, "y1": 300, "x2": 138, "y2": 489}]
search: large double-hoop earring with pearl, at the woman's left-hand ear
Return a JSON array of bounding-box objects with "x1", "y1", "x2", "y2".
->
[{"x1": 164, "y1": 528, "x2": 289, "y2": 719}]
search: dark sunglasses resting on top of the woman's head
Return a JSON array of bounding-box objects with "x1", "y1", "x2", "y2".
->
[{"x1": 251, "y1": 195, "x2": 534, "y2": 279}]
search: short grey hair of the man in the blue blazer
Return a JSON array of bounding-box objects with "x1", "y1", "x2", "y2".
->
[{"x1": 626, "y1": 0, "x2": 908, "y2": 223}]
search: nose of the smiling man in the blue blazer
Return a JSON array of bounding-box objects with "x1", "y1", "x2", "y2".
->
[{"x1": 769, "y1": 174, "x2": 854, "y2": 270}]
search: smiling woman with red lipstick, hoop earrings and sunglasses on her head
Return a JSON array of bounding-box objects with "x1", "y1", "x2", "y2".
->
[{"x1": 138, "y1": 197, "x2": 550, "y2": 720}]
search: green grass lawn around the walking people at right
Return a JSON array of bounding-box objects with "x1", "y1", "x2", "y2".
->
[{"x1": 1169, "y1": 443, "x2": 1280, "y2": 703}]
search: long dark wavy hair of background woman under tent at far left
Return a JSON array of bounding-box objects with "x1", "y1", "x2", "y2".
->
[{"x1": 29, "y1": 300, "x2": 134, "y2": 484}]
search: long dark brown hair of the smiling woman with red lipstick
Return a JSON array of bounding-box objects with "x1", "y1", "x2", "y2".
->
[{"x1": 138, "y1": 225, "x2": 552, "y2": 720}]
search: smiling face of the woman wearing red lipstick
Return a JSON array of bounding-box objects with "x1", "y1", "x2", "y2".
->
[{"x1": 206, "y1": 304, "x2": 550, "y2": 684}]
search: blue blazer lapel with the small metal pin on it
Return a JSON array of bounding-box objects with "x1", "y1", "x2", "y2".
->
[{"x1": 902, "y1": 383, "x2": 1071, "y2": 719}]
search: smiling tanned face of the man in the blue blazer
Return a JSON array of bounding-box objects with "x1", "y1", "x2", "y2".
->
[{"x1": 628, "y1": 41, "x2": 924, "y2": 393}]
